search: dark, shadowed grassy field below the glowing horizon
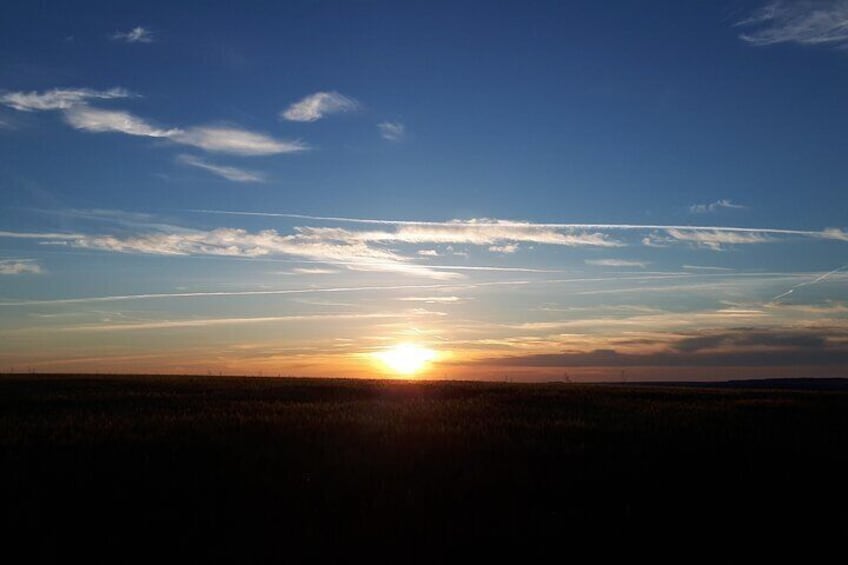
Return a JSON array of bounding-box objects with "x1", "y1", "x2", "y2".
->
[{"x1": 0, "y1": 375, "x2": 848, "y2": 563}]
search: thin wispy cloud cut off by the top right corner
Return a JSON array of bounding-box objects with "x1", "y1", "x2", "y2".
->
[{"x1": 736, "y1": 0, "x2": 848, "y2": 48}]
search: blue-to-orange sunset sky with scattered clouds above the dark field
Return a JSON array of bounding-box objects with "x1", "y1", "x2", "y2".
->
[{"x1": 0, "y1": 0, "x2": 848, "y2": 382}]
